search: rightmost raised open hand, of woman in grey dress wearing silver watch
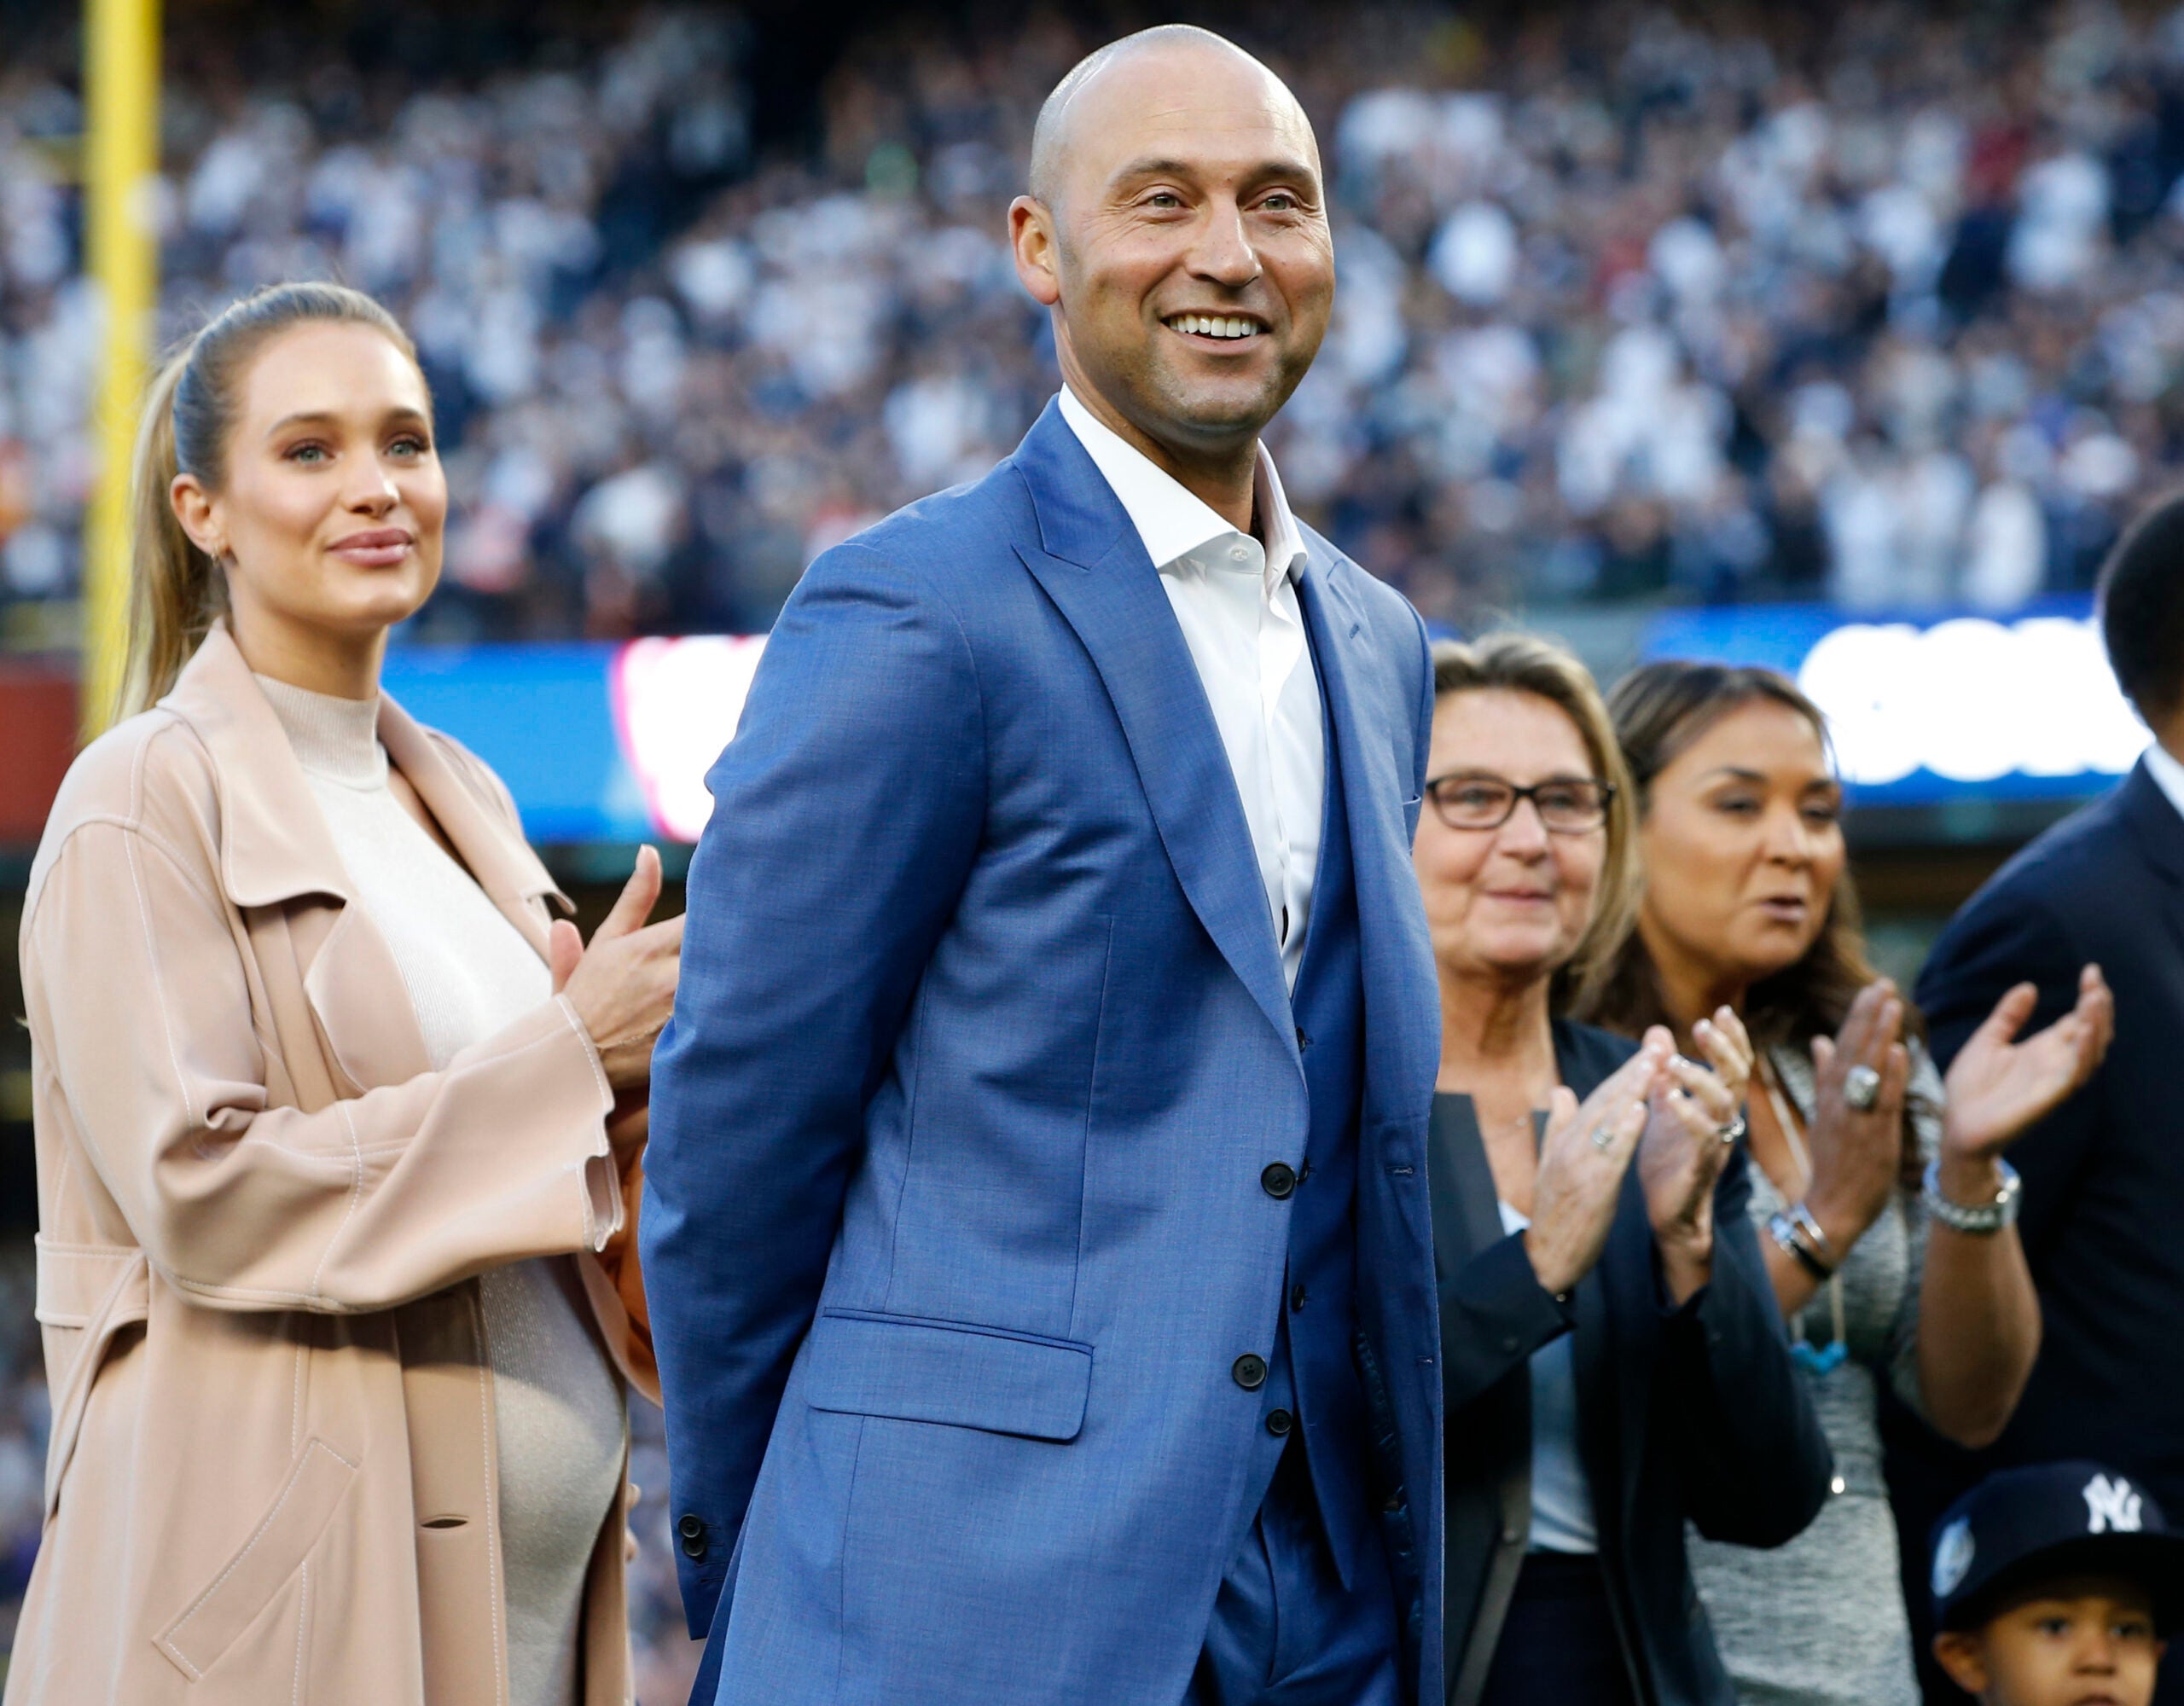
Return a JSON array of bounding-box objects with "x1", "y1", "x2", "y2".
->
[{"x1": 1942, "y1": 966, "x2": 2117, "y2": 1162}]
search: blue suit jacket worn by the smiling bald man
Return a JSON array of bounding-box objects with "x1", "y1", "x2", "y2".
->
[{"x1": 642, "y1": 409, "x2": 1442, "y2": 1706}]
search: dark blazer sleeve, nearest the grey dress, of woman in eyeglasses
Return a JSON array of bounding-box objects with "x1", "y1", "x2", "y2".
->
[{"x1": 1653, "y1": 1149, "x2": 1834, "y2": 1546}]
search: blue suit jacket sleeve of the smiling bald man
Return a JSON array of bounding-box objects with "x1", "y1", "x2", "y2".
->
[{"x1": 640, "y1": 544, "x2": 985, "y2": 1636}]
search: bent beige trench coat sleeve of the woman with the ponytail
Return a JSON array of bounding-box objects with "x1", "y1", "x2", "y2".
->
[{"x1": 24, "y1": 819, "x2": 623, "y2": 1315}]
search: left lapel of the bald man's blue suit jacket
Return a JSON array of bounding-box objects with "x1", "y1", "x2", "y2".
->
[{"x1": 1015, "y1": 406, "x2": 1302, "y2": 1044}]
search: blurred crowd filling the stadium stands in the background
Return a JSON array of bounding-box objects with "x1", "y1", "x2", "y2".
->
[{"x1": 0, "y1": 4, "x2": 2184, "y2": 638}]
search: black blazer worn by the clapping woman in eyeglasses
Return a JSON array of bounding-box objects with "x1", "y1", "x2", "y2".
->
[{"x1": 1428, "y1": 1020, "x2": 1834, "y2": 1706}]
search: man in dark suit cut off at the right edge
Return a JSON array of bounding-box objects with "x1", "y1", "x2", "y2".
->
[{"x1": 1898, "y1": 498, "x2": 2184, "y2": 1699}]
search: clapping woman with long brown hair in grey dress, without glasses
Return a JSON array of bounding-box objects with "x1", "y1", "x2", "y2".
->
[{"x1": 1588, "y1": 662, "x2": 2114, "y2": 1706}]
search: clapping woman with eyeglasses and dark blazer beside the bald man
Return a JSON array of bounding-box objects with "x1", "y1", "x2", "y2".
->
[{"x1": 1415, "y1": 634, "x2": 1830, "y2": 1706}]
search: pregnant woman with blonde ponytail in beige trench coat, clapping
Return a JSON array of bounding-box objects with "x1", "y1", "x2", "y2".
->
[{"x1": 7, "y1": 286, "x2": 682, "y2": 1706}]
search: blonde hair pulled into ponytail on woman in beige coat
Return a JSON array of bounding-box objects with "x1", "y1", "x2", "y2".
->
[{"x1": 120, "y1": 284, "x2": 417, "y2": 717}]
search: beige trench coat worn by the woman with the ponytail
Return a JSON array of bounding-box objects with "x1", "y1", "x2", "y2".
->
[{"x1": 7, "y1": 630, "x2": 658, "y2": 1706}]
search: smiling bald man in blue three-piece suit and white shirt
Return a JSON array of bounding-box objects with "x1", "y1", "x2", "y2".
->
[{"x1": 642, "y1": 26, "x2": 1442, "y2": 1706}]
